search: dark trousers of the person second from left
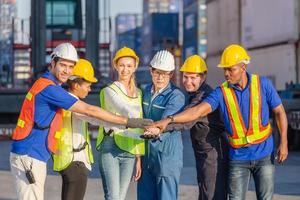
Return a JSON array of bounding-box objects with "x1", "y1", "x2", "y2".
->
[{"x1": 60, "y1": 161, "x2": 89, "y2": 200}]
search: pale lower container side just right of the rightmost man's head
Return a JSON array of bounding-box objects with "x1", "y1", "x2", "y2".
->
[{"x1": 248, "y1": 44, "x2": 297, "y2": 90}]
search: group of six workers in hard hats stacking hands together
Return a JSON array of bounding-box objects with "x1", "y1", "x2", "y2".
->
[{"x1": 10, "y1": 43, "x2": 288, "y2": 200}]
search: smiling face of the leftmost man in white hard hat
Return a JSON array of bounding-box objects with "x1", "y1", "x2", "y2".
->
[{"x1": 50, "y1": 58, "x2": 75, "y2": 84}]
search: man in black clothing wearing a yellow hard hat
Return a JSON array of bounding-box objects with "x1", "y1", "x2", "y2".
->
[{"x1": 177, "y1": 55, "x2": 228, "y2": 200}]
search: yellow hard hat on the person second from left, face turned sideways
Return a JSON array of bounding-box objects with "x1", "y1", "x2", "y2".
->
[{"x1": 69, "y1": 59, "x2": 98, "y2": 83}]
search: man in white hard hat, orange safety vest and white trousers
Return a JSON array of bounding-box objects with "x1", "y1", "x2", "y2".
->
[{"x1": 10, "y1": 43, "x2": 149, "y2": 200}]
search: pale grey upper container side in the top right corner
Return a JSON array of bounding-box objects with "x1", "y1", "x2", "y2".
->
[{"x1": 241, "y1": 0, "x2": 300, "y2": 48}]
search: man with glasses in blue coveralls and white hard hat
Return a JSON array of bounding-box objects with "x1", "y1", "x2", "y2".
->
[{"x1": 137, "y1": 50, "x2": 185, "y2": 200}]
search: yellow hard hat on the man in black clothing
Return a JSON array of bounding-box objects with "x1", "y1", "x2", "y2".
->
[{"x1": 180, "y1": 55, "x2": 207, "y2": 73}]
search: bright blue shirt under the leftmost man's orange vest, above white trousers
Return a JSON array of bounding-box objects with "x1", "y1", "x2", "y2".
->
[{"x1": 11, "y1": 72, "x2": 77, "y2": 162}]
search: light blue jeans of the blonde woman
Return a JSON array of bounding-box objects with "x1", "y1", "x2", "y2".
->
[{"x1": 99, "y1": 136, "x2": 135, "y2": 200}]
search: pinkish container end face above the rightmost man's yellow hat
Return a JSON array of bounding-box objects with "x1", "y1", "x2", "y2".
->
[{"x1": 207, "y1": 0, "x2": 240, "y2": 56}]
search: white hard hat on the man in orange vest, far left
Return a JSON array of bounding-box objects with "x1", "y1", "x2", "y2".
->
[{"x1": 51, "y1": 43, "x2": 78, "y2": 62}]
